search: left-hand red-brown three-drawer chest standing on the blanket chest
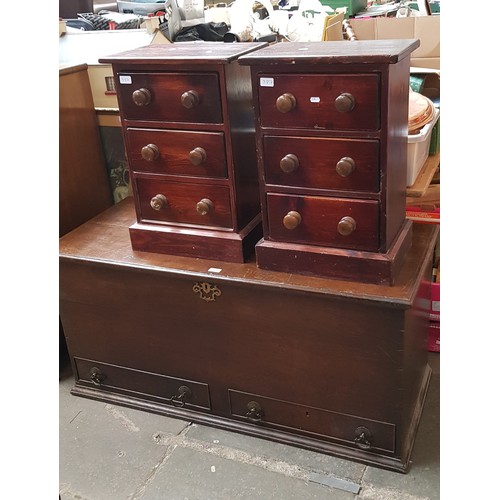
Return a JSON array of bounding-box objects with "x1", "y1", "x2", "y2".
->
[{"x1": 100, "y1": 42, "x2": 266, "y2": 262}]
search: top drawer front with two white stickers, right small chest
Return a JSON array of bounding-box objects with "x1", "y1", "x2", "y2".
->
[{"x1": 259, "y1": 74, "x2": 380, "y2": 130}]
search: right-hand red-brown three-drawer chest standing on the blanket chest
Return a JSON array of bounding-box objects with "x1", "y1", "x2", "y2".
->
[{"x1": 239, "y1": 40, "x2": 419, "y2": 283}]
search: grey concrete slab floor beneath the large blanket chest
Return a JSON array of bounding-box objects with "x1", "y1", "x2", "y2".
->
[{"x1": 59, "y1": 353, "x2": 440, "y2": 500}]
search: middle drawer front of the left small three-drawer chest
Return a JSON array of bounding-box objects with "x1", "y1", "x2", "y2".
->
[{"x1": 127, "y1": 128, "x2": 227, "y2": 178}]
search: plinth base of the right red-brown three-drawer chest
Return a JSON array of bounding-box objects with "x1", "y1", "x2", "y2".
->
[{"x1": 255, "y1": 220, "x2": 413, "y2": 285}]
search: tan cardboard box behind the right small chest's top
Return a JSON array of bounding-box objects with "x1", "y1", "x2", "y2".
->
[{"x1": 327, "y1": 15, "x2": 441, "y2": 69}]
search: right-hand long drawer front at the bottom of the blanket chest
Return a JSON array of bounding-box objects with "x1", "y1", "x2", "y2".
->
[{"x1": 229, "y1": 389, "x2": 395, "y2": 452}]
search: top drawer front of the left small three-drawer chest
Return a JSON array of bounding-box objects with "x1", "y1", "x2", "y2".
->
[{"x1": 117, "y1": 72, "x2": 222, "y2": 123}]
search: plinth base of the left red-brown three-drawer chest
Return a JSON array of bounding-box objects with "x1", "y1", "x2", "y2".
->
[{"x1": 129, "y1": 215, "x2": 262, "y2": 263}]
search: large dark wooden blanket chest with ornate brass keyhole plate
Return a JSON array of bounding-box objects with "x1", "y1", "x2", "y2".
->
[{"x1": 60, "y1": 198, "x2": 437, "y2": 471}]
